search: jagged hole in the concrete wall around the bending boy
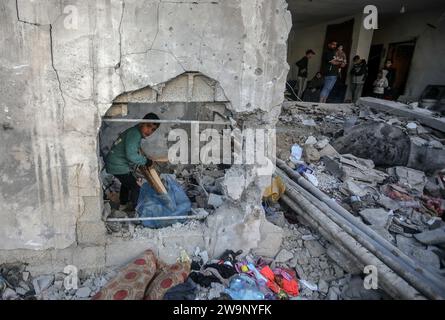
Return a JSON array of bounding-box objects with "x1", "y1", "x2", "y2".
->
[{"x1": 99, "y1": 73, "x2": 231, "y2": 236}]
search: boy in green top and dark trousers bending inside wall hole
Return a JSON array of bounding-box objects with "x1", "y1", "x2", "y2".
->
[{"x1": 105, "y1": 113, "x2": 160, "y2": 211}]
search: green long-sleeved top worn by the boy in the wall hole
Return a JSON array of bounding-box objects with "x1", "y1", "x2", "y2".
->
[{"x1": 105, "y1": 125, "x2": 147, "y2": 175}]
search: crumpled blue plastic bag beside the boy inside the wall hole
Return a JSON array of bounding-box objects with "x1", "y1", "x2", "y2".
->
[{"x1": 136, "y1": 175, "x2": 192, "y2": 229}]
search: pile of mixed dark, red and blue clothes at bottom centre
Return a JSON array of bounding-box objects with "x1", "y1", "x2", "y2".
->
[{"x1": 164, "y1": 250, "x2": 299, "y2": 300}]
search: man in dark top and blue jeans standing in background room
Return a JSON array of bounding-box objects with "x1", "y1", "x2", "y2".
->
[{"x1": 320, "y1": 41, "x2": 342, "y2": 103}]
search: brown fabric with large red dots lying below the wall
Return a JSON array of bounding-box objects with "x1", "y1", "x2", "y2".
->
[{"x1": 92, "y1": 250, "x2": 190, "y2": 300}]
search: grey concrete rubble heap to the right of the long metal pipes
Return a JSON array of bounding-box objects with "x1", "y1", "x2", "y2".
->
[{"x1": 277, "y1": 105, "x2": 445, "y2": 276}]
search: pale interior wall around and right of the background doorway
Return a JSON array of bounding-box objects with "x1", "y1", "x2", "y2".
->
[{"x1": 373, "y1": 10, "x2": 445, "y2": 96}]
